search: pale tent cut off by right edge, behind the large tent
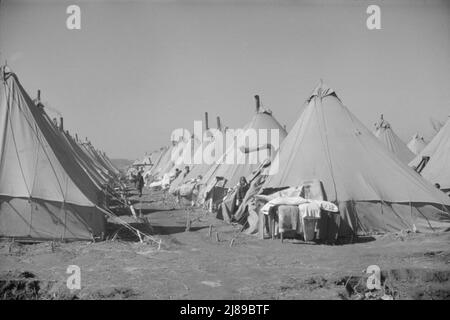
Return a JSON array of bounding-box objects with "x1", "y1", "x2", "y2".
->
[{"x1": 410, "y1": 119, "x2": 450, "y2": 191}]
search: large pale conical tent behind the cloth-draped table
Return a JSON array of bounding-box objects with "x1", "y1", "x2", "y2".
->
[{"x1": 264, "y1": 84, "x2": 450, "y2": 235}]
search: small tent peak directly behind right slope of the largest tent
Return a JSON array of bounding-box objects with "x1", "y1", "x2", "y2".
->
[{"x1": 374, "y1": 116, "x2": 414, "y2": 164}]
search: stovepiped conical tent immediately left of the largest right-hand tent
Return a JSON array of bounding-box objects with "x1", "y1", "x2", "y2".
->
[{"x1": 202, "y1": 111, "x2": 287, "y2": 190}]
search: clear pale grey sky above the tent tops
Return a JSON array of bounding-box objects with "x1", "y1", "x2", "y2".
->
[{"x1": 0, "y1": 0, "x2": 450, "y2": 159}]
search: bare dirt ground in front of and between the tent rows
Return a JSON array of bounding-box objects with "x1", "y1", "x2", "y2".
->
[{"x1": 0, "y1": 189, "x2": 450, "y2": 299}]
